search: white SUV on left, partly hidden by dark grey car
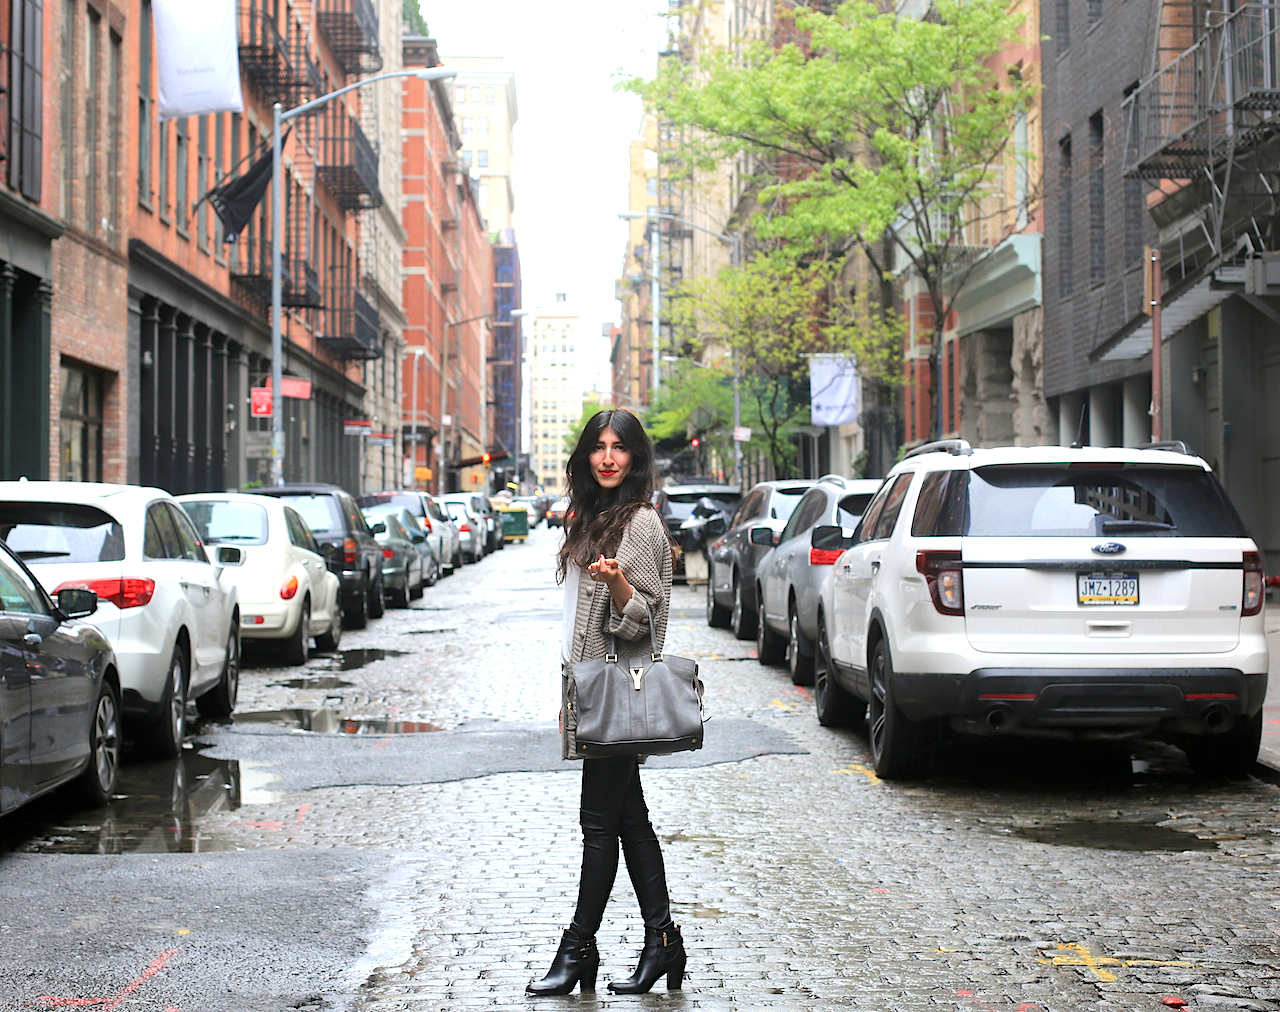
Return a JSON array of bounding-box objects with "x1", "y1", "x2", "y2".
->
[{"x1": 0, "y1": 481, "x2": 243, "y2": 756}]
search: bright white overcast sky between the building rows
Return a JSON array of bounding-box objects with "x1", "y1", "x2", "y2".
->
[{"x1": 421, "y1": 0, "x2": 668, "y2": 376}]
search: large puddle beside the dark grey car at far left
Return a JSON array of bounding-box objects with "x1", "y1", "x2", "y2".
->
[{"x1": 0, "y1": 748, "x2": 243, "y2": 853}]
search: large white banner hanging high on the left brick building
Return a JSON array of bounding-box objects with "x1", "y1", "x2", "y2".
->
[{"x1": 151, "y1": 0, "x2": 244, "y2": 119}]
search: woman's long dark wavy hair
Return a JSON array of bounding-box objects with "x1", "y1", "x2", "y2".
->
[{"x1": 557, "y1": 408, "x2": 658, "y2": 582}]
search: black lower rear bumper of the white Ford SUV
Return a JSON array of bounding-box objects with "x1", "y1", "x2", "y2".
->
[{"x1": 892, "y1": 668, "x2": 1267, "y2": 736}]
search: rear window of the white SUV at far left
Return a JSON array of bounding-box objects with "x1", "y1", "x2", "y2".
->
[{"x1": 0, "y1": 503, "x2": 124, "y2": 565}]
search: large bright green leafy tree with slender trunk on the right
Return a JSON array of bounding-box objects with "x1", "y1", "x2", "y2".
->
[{"x1": 625, "y1": 0, "x2": 1034, "y2": 442}]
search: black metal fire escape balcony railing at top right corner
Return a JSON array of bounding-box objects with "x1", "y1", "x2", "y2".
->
[{"x1": 1121, "y1": 4, "x2": 1280, "y2": 179}]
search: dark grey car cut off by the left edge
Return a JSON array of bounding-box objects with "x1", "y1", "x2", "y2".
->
[{"x1": 0, "y1": 537, "x2": 120, "y2": 814}]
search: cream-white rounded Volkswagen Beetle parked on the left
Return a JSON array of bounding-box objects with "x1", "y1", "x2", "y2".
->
[{"x1": 178, "y1": 493, "x2": 342, "y2": 664}]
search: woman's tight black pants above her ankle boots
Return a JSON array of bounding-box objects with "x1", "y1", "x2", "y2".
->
[{"x1": 572, "y1": 756, "x2": 671, "y2": 938}]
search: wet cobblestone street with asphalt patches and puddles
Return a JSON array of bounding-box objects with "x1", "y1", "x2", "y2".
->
[{"x1": 0, "y1": 530, "x2": 1280, "y2": 1012}]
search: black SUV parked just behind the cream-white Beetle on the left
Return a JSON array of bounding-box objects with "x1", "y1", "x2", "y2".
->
[{"x1": 255, "y1": 484, "x2": 385, "y2": 629}]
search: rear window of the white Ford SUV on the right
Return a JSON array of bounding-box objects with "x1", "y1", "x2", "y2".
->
[{"x1": 948, "y1": 464, "x2": 1248, "y2": 537}]
